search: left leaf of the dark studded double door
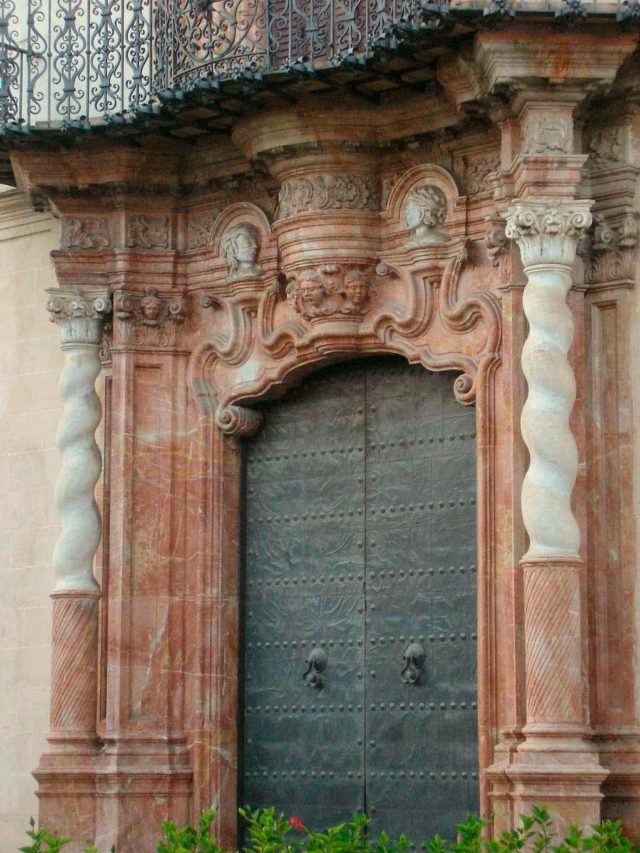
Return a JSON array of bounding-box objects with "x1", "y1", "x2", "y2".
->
[{"x1": 241, "y1": 364, "x2": 365, "y2": 827}]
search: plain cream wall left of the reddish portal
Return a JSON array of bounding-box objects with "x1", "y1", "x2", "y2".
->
[{"x1": 0, "y1": 191, "x2": 63, "y2": 853}]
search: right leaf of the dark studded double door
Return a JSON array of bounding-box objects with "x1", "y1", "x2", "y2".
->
[{"x1": 365, "y1": 364, "x2": 477, "y2": 839}]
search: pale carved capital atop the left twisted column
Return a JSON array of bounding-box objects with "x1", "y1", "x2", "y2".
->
[{"x1": 47, "y1": 289, "x2": 111, "y2": 347}]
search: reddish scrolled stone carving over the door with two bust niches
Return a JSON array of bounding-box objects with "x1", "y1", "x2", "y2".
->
[{"x1": 190, "y1": 166, "x2": 500, "y2": 435}]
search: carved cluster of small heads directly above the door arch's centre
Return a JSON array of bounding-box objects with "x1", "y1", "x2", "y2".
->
[{"x1": 287, "y1": 265, "x2": 371, "y2": 321}]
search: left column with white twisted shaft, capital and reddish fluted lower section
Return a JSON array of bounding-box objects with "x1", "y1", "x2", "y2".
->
[{"x1": 47, "y1": 290, "x2": 111, "y2": 751}]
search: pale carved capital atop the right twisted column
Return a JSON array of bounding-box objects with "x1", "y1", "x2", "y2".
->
[{"x1": 505, "y1": 200, "x2": 593, "y2": 269}]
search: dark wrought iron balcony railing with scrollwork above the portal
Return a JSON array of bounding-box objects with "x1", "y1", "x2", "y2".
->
[{"x1": 0, "y1": 0, "x2": 640, "y2": 138}]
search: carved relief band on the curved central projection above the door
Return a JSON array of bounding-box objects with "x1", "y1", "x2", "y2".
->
[{"x1": 279, "y1": 175, "x2": 380, "y2": 219}]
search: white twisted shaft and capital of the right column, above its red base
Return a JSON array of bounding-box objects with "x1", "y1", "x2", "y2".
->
[{"x1": 506, "y1": 201, "x2": 591, "y2": 560}]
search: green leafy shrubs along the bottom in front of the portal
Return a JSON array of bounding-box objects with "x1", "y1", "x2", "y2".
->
[{"x1": 20, "y1": 808, "x2": 640, "y2": 853}]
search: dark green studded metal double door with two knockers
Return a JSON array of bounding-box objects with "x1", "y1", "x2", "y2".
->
[{"x1": 240, "y1": 357, "x2": 478, "y2": 841}]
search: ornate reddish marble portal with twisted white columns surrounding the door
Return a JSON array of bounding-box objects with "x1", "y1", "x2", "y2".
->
[{"x1": 7, "y1": 18, "x2": 640, "y2": 853}]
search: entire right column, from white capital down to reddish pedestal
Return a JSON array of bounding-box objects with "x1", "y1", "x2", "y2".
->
[{"x1": 506, "y1": 199, "x2": 606, "y2": 823}]
